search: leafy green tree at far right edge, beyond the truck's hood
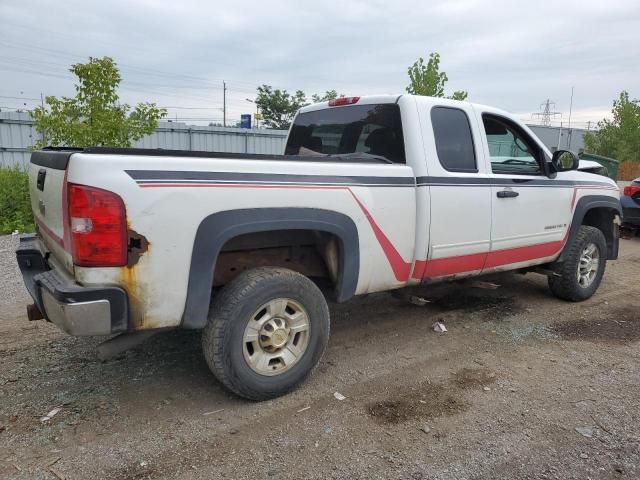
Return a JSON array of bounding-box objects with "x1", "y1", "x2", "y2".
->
[{"x1": 584, "y1": 91, "x2": 640, "y2": 161}]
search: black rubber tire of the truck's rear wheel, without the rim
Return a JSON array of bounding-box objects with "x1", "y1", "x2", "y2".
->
[{"x1": 202, "y1": 267, "x2": 329, "y2": 400}]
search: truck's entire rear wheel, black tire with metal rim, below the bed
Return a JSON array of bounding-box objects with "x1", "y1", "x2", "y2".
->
[{"x1": 202, "y1": 267, "x2": 329, "y2": 400}]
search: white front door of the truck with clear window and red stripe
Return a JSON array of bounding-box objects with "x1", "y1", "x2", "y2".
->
[{"x1": 476, "y1": 107, "x2": 573, "y2": 271}]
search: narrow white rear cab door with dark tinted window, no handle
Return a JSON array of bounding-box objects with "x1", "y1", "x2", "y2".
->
[{"x1": 414, "y1": 97, "x2": 491, "y2": 280}]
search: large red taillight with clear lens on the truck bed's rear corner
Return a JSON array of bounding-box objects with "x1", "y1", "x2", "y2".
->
[{"x1": 68, "y1": 183, "x2": 127, "y2": 267}]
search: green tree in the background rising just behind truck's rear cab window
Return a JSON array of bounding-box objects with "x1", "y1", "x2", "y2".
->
[{"x1": 255, "y1": 85, "x2": 307, "y2": 130}]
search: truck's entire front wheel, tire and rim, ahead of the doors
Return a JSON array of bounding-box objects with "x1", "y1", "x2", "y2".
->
[{"x1": 549, "y1": 225, "x2": 607, "y2": 302}]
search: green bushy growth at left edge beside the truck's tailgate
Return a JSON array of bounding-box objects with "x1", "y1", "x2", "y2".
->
[{"x1": 0, "y1": 165, "x2": 34, "y2": 233}]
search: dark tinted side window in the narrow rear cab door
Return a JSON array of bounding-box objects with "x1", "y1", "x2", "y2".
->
[{"x1": 431, "y1": 107, "x2": 478, "y2": 173}]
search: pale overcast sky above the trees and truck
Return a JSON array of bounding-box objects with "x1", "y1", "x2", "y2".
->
[{"x1": 0, "y1": 0, "x2": 640, "y2": 126}]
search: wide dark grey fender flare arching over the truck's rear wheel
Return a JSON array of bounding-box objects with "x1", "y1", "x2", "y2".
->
[{"x1": 181, "y1": 208, "x2": 360, "y2": 328}]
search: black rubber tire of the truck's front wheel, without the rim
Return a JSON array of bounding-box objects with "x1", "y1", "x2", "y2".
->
[{"x1": 549, "y1": 225, "x2": 607, "y2": 302}]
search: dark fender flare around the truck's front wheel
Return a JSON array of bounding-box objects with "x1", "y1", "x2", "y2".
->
[{"x1": 556, "y1": 195, "x2": 622, "y2": 262}]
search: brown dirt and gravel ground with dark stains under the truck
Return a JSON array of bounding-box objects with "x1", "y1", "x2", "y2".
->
[{"x1": 0, "y1": 238, "x2": 640, "y2": 480}]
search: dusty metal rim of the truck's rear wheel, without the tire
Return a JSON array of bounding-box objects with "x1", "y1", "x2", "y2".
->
[{"x1": 242, "y1": 298, "x2": 311, "y2": 376}]
